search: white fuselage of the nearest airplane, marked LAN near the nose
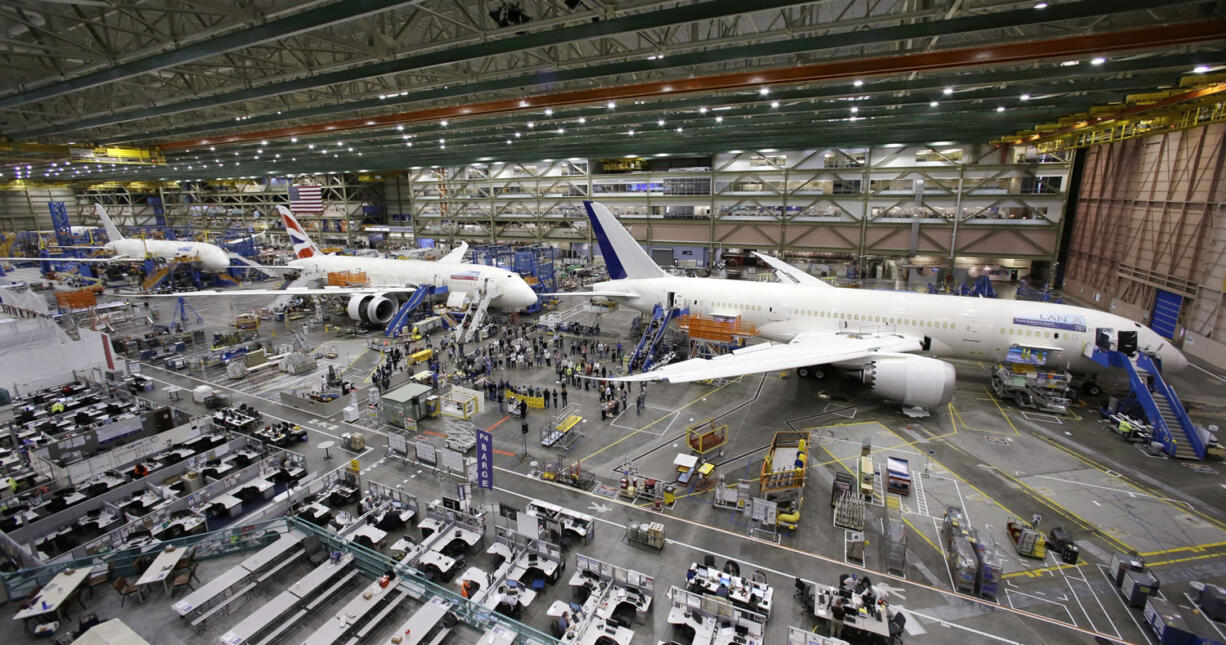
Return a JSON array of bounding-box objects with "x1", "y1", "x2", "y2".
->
[{"x1": 593, "y1": 277, "x2": 1187, "y2": 373}]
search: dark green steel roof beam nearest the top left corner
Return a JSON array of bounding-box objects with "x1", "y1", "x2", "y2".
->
[{"x1": 0, "y1": 0, "x2": 419, "y2": 109}]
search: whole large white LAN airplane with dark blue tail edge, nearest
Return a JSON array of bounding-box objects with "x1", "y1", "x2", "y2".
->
[{"x1": 568, "y1": 201, "x2": 1188, "y2": 410}]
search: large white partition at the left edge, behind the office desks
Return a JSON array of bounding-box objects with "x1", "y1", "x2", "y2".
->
[{"x1": 0, "y1": 318, "x2": 114, "y2": 397}]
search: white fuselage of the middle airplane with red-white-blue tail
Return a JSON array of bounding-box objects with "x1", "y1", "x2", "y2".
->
[{"x1": 288, "y1": 255, "x2": 537, "y2": 310}]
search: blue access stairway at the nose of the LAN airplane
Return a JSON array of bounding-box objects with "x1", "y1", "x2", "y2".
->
[{"x1": 1085, "y1": 345, "x2": 1208, "y2": 459}]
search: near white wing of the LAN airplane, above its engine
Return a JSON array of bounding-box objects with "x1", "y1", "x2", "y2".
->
[{"x1": 608, "y1": 331, "x2": 921, "y2": 383}]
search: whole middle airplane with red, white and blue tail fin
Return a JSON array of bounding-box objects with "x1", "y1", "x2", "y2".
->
[{"x1": 145, "y1": 206, "x2": 537, "y2": 325}]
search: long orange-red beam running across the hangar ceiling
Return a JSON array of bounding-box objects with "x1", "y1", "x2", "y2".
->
[{"x1": 161, "y1": 20, "x2": 1226, "y2": 151}]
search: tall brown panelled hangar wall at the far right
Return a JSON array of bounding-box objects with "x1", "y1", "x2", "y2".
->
[{"x1": 1064, "y1": 124, "x2": 1226, "y2": 364}]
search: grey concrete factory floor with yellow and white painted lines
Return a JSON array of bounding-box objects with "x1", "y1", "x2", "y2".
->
[{"x1": 6, "y1": 280, "x2": 1226, "y2": 644}]
